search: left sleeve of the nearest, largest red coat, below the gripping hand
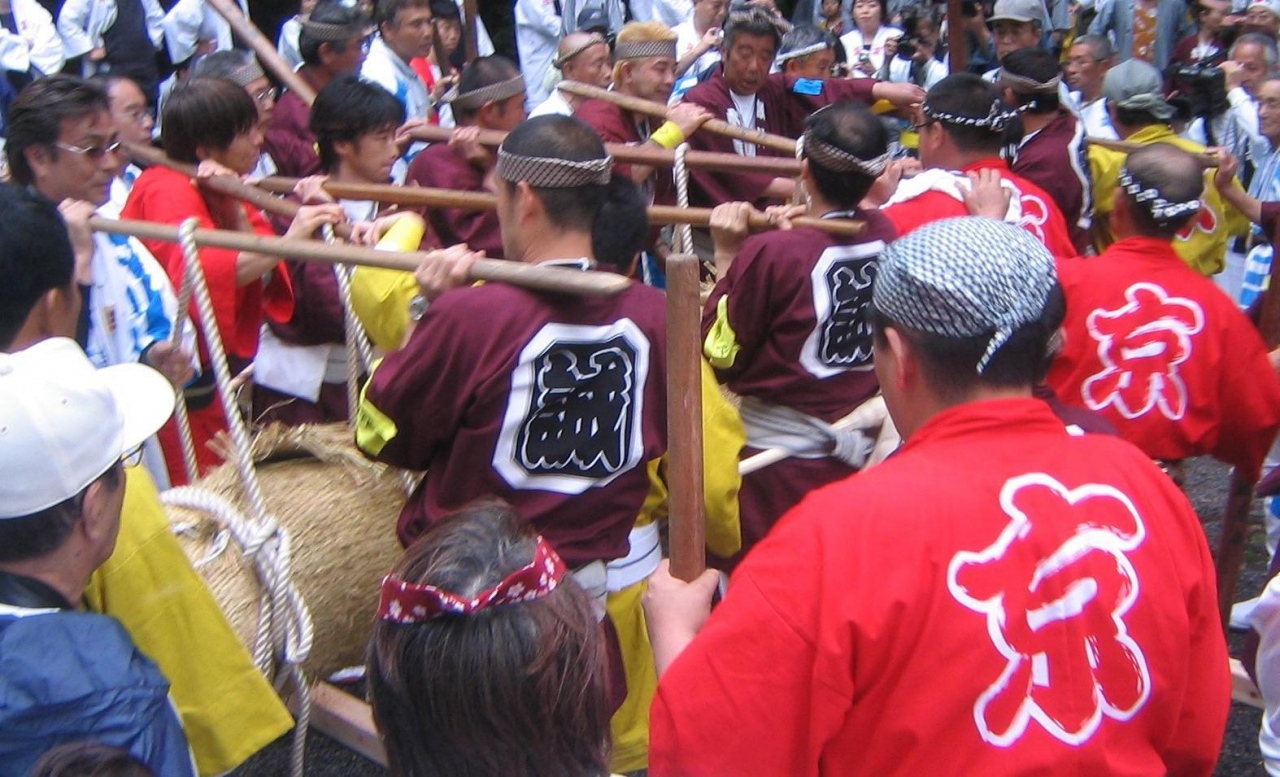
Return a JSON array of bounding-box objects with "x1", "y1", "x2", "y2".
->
[{"x1": 649, "y1": 513, "x2": 852, "y2": 777}]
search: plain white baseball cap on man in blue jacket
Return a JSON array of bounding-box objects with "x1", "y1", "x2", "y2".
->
[{"x1": 0, "y1": 338, "x2": 174, "y2": 520}]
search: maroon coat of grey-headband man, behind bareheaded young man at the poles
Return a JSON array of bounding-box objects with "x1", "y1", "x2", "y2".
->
[{"x1": 406, "y1": 143, "x2": 502, "y2": 259}]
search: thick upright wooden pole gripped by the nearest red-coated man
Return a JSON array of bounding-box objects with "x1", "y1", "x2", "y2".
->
[{"x1": 667, "y1": 253, "x2": 707, "y2": 581}]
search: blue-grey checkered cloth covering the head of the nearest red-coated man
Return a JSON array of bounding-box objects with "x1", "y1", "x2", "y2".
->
[{"x1": 872, "y1": 216, "x2": 1057, "y2": 375}]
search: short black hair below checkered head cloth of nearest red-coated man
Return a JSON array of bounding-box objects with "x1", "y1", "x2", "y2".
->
[{"x1": 870, "y1": 283, "x2": 1066, "y2": 399}]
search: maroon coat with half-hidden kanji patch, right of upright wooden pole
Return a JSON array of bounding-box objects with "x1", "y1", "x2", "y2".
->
[{"x1": 703, "y1": 211, "x2": 895, "y2": 558}]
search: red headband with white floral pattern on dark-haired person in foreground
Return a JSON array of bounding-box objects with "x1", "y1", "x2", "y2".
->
[{"x1": 378, "y1": 536, "x2": 566, "y2": 625}]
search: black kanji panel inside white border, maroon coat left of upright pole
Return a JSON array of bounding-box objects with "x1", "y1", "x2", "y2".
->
[{"x1": 516, "y1": 334, "x2": 639, "y2": 479}]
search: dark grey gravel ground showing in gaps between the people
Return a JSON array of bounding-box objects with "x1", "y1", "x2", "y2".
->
[{"x1": 233, "y1": 460, "x2": 1267, "y2": 777}]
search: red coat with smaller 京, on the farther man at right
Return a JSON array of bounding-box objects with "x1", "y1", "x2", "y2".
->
[{"x1": 1048, "y1": 237, "x2": 1280, "y2": 475}]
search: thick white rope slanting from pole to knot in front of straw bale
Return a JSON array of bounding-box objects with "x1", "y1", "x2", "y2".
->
[{"x1": 170, "y1": 219, "x2": 314, "y2": 777}]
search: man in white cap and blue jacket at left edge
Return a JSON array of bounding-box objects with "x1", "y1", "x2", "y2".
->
[{"x1": 0, "y1": 338, "x2": 196, "y2": 777}]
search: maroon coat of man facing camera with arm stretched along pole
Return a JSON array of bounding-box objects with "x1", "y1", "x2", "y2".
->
[{"x1": 684, "y1": 69, "x2": 876, "y2": 207}]
